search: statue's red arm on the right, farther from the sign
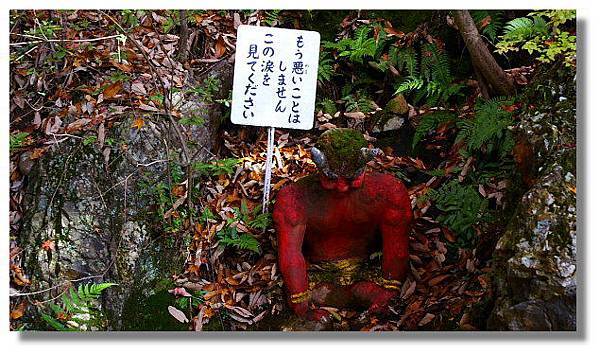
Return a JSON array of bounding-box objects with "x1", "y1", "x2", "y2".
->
[{"x1": 380, "y1": 181, "x2": 412, "y2": 288}]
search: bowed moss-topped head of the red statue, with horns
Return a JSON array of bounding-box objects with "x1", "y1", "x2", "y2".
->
[{"x1": 311, "y1": 128, "x2": 380, "y2": 192}]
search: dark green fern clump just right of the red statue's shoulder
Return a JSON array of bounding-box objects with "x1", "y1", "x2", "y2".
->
[{"x1": 427, "y1": 180, "x2": 488, "y2": 245}]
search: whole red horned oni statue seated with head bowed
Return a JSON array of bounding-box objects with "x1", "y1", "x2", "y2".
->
[{"x1": 273, "y1": 128, "x2": 412, "y2": 320}]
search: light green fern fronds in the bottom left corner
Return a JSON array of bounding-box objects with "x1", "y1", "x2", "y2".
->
[{"x1": 40, "y1": 282, "x2": 117, "y2": 331}]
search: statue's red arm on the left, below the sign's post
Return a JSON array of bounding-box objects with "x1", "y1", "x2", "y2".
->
[{"x1": 273, "y1": 190, "x2": 309, "y2": 316}]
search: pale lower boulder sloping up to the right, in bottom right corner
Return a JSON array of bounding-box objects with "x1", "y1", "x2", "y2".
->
[{"x1": 488, "y1": 149, "x2": 577, "y2": 330}]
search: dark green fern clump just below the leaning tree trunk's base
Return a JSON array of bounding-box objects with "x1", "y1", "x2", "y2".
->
[{"x1": 456, "y1": 97, "x2": 514, "y2": 157}]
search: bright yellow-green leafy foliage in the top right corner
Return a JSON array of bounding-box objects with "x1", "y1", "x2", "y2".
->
[{"x1": 496, "y1": 10, "x2": 577, "y2": 67}]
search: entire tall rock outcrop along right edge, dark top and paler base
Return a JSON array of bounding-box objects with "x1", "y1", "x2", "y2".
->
[{"x1": 488, "y1": 66, "x2": 577, "y2": 330}]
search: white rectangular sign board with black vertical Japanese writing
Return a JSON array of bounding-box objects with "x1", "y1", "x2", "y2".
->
[{"x1": 231, "y1": 25, "x2": 321, "y2": 130}]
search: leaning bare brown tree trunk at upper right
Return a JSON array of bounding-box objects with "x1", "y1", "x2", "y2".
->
[{"x1": 453, "y1": 10, "x2": 515, "y2": 96}]
